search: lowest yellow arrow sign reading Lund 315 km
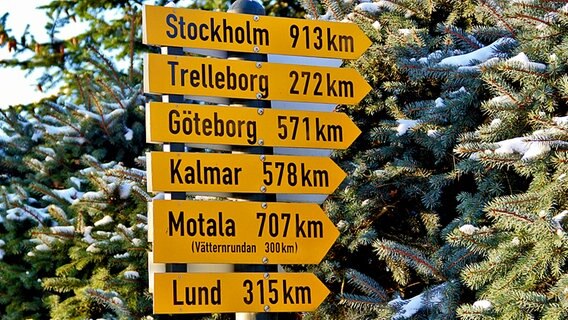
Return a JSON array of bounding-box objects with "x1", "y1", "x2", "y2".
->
[{"x1": 154, "y1": 272, "x2": 329, "y2": 314}]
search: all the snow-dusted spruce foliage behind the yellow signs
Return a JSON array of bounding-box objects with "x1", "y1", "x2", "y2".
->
[{"x1": 0, "y1": 0, "x2": 568, "y2": 319}]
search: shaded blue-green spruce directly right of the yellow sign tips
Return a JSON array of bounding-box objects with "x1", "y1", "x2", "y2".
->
[{"x1": 298, "y1": 1, "x2": 524, "y2": 319}]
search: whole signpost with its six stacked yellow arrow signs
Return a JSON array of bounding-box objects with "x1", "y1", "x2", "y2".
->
[{"x1": 143, "y1": 0, "x2": 371, "y2": 314}]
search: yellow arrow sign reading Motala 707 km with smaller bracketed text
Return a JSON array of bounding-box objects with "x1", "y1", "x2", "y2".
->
[{"x1": 149, "y1": 200, "x2": 339, "y2": 264}]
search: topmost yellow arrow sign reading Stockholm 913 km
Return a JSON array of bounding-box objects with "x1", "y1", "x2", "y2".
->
[{"x1": 142, "y1": 6, "x2": 371, "y2": 59}]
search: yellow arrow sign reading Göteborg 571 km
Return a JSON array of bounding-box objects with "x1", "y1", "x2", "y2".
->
[{"x1": 146, "y1": 102, "x2": 361, "y2": 149}]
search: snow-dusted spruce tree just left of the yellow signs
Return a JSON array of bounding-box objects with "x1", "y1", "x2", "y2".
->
[{"x1": 2, "y1": 49, "x2": 151, "y2": 319}]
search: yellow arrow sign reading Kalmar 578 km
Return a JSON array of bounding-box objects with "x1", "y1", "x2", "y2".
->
[{"x1": 146, "y1": 152, "x2": 346, "y2": 194}]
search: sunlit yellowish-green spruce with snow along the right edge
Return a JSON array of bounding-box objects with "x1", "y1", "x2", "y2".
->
[{"x1": 448, "y1": 0, "x2": 568, "y2": 319}]
